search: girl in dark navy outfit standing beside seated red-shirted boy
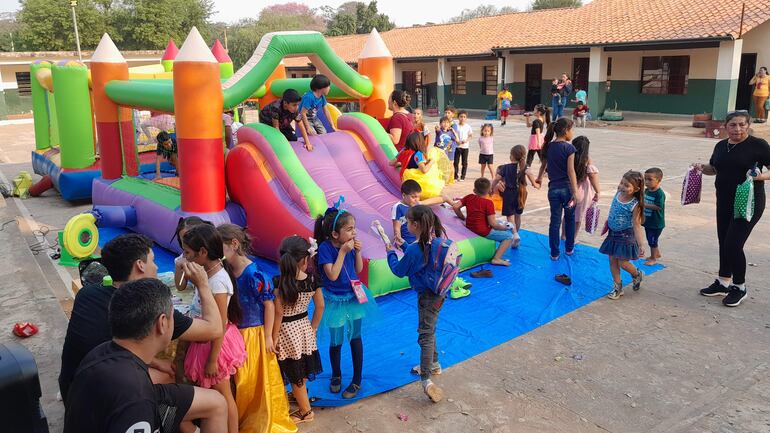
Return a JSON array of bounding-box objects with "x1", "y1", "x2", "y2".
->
[{"x1": 491, "y1": 144, "x2": 540, "y2": 248}]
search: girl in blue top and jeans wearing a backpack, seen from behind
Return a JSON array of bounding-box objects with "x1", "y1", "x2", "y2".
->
[{"x1": 385, "y1": 205, "x2": 446, "y2": 403}]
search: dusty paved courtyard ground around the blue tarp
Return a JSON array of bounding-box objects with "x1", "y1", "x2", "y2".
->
[{"x1": 0, "y1": 115, "x2": 770, "y2": 433}]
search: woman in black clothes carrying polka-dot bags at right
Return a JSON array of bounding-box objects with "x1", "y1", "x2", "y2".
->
[{"x1": 695, "y1": 111, "x2": 770, "y2": 307}]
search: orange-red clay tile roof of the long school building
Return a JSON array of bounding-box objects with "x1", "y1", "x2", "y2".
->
[{"x1": 286, "y1": 0, "x2": 770, "y2": 67}]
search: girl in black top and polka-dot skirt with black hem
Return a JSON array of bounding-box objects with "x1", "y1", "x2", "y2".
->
[{"x1": 272, "y1": 235, "x2": 324, "y2": 424}]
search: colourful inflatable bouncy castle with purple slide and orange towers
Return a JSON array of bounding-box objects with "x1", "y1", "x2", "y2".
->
[{"x1": 42, "y1": 28, "x2": 495, "y2": 295}]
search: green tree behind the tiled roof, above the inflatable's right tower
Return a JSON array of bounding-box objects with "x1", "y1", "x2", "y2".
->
[{"x1": 322, "y1": 0, "x2": 396, "y2": 36}]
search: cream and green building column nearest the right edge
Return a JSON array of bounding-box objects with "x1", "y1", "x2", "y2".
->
[{"x1": 711, "y1": 39, "x2": 743, "y2": 120}]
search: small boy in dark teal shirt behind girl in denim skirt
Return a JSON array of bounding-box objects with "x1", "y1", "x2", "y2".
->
[{"x1": 644, "y1": 167, "x2": 666, "y2": 266}]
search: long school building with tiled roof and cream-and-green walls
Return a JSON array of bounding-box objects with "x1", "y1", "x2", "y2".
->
[{"x1": 286, "y1": 0, "x2": 770, "y2": 119}]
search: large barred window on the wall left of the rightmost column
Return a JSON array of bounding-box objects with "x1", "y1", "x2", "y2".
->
[{"x1": 641, "y1": 56, "x2": 690, "y2": 95}]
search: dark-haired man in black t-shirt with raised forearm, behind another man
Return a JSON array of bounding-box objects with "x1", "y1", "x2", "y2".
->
[{"x1": 59, "y1": 234, "x2": 222, "y2": 404}]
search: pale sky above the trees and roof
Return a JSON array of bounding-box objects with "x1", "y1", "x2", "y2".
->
[{"x1": 0, "y1": 0, "x2": 585, "y2": 27}]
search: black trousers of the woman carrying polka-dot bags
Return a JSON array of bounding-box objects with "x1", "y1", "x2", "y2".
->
[{"x1": 717, "y1": 186, "x2": 765, "y2": 284}]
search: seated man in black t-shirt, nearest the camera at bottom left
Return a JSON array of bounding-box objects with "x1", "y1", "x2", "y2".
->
[{"x1": 64, "y1": 278, "x2": 227, "y2": 433}]
